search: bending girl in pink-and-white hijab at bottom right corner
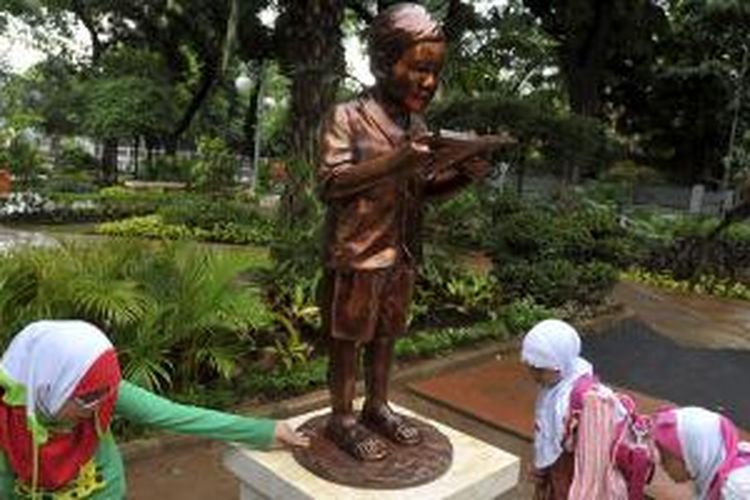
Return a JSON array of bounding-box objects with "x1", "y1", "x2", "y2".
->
[{"x1": 654, "y1": 407, "x2": 750, "y2": 500}]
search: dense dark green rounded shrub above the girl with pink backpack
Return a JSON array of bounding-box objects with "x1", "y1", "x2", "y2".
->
[{"x1": 490, "y1": 196, "x2": 635, "y2": 306}]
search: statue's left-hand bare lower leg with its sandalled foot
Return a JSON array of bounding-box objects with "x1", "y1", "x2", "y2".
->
[{"x1": 326, "y1": 339, "x2": 388, "y2": 461}]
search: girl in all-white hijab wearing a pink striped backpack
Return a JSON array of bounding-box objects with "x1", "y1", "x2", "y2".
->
[{"x1": 521, "y1": 319, "x2": 652, "y2": 500}]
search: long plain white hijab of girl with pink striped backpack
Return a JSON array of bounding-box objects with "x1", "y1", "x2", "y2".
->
[{"x1": 521, "y1": 319, "x2": 593, "y2": 469}]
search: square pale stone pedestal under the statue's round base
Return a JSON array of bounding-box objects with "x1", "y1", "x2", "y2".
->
[{"x1": 224, "y1": 406, "x2": 520, "y2": 500}]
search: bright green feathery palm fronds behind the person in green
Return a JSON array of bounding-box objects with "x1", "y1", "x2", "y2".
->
[{"x1": 0, "y1": 240, "x2": 273, "y2": 388}]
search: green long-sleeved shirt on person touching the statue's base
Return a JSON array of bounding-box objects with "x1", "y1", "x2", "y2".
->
[{"x1": 0, "y1": 381, "x2": 275, "y2": 500}]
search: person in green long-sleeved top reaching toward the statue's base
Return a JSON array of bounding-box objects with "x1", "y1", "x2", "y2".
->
[{"x1": 0, "y1": 321, "x2": 309, "y2": 500}]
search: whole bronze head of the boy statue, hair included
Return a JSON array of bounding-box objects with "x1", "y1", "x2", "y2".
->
[{"x1": 368, "y1": 3, "x2": 446, "y2": 113}]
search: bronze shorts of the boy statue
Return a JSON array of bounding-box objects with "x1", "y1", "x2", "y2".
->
[{"x1": 321, "y1": 264, "x2": 416, "y2": 342}]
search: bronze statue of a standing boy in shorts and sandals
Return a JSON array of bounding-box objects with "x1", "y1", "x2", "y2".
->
[{"x1": 317, "y1": 4, "x2": 500, "y2": 461}]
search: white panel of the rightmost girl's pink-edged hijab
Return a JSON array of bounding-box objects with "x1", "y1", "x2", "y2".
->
[{"x1": 675, "y1": 407, "x2": 725, "y2": 500}]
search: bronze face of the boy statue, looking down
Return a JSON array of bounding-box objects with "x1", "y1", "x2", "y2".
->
[{"x1": 386, "y1": 41, "x2": 445, "y2": 113}]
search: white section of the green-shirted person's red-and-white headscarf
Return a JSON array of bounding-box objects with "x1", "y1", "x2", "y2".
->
[{"x1": 0, "y1": 320, "x2": 113, "y2": 418}]
